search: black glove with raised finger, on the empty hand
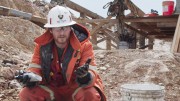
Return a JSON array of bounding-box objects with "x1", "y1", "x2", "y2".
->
[{"x1": 75, "y1": 59, "x2": 91, "y2": 84}]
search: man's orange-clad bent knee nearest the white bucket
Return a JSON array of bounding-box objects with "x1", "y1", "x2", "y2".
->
[{"x1": 74, "y1": 87, "x2": 101, "y2": 101}]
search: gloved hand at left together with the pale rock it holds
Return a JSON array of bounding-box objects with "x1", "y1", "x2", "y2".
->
[{"x1": 15, "y1": 70, "x2": 42, "y2": 88}]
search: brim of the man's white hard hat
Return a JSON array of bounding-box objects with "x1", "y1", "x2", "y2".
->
[{"x1": 44, "y1": 21, "x2": 76, "y2": 28}]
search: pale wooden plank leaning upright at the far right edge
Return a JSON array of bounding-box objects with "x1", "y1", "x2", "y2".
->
[{"x1": 171, "y1": 15, "x2": 180, "y2": 53}]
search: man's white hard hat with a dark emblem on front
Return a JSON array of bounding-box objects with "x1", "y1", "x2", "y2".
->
[{"x1": 44, "y1": 5, "x2": 76, "y2": 28}]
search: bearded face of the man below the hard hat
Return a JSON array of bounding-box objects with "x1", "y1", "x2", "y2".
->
[{"x1": 52, "y1": 26, "x2": 71, "y2": 48}]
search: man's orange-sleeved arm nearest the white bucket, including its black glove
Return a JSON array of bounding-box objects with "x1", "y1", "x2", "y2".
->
[{"x1": 76, "y1": 41, "x2": 97, "y2": 87}]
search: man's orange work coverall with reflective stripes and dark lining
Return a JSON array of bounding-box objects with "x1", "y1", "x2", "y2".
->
[{"x1": 19, "y1": 24, "x2": 106, "y2": 101}]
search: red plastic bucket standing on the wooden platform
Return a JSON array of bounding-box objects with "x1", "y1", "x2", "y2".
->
[{"x1": 162, "y1": 0, "x2": 174, "y2": 16}]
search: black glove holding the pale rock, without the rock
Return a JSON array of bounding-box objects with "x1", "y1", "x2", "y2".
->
[{"x1": 15, "y1": 70, "x2": 38, "y2": 88}]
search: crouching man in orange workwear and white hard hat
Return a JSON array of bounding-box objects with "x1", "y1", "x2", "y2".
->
[{"x1": 18, "y1": 6, "x2": 106, "y2": 101}]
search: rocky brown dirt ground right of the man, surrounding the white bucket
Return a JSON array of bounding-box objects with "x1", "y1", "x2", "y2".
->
[{"x1": 95, "y1": 50, "x2": 180, "y2": 101}]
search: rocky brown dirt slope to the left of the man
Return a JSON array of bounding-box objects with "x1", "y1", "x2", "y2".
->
[{"x1": 0, "y1": 16, "x2": 44, "y2": 101}]
